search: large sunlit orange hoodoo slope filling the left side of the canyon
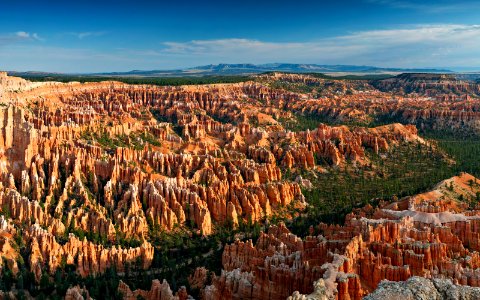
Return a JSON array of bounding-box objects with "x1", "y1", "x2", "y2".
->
[{"x1": 0, "y1": 73, "x2": 312, "y2": 284}]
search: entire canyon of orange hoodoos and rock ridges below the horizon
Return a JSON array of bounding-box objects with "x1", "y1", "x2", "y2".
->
[{"x1": 0, "y1": 73, "x2": 480, "y2": 299}]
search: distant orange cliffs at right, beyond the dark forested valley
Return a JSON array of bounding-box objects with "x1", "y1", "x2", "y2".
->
[{"x1": 260, "y1": 73, "x2": 480, "y2": 134}]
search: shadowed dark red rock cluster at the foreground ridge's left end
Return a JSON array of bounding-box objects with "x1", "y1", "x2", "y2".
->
[{"x1": 205, "y1": 225, "x2": 327, "y2": 299}]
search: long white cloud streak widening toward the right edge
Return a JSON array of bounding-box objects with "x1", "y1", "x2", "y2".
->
[{"x1": 158, "y1": 25, "x2": 480, "y2": 67}]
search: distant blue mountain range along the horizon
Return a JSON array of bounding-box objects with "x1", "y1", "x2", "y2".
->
[{"x1": 9, "y1": 63, "x2": 452, "y2": 77}]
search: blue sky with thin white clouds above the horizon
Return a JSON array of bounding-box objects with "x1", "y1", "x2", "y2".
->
[{"x1": 0, "y1": 0, "x2": 480, "y2": 73}]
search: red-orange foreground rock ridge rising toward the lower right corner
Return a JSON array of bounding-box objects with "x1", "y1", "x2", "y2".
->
[{"x1": 205, "y1": 173, "x2": 480, "y2": 299}]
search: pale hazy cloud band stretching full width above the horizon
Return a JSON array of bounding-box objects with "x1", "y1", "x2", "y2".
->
[{"x1": 0, "y1": 24, "x2": 480, "y2": 72}]
